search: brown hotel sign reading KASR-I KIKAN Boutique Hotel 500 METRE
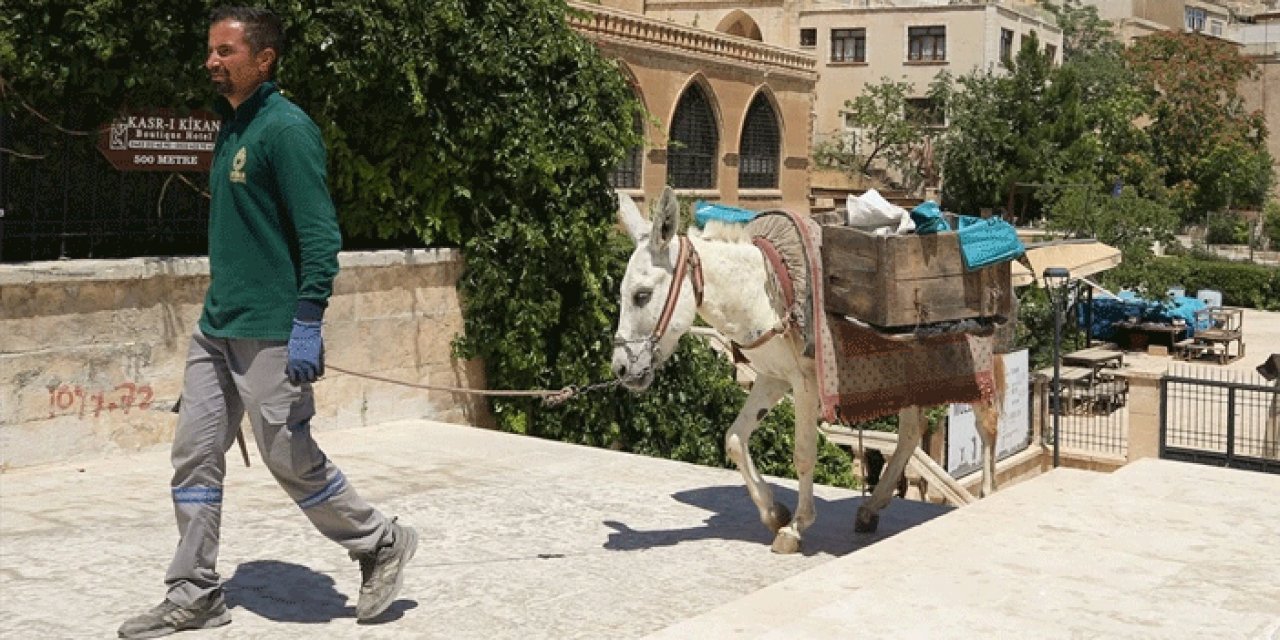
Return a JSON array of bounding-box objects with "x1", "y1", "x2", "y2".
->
[{"x1": 97, "y1": 109, "x2": 221, "y2": 173}]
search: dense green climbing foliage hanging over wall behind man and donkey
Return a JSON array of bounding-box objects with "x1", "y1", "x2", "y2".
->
[{"x1": 0, "y1": 0, "x2": 849, "y2": 483}]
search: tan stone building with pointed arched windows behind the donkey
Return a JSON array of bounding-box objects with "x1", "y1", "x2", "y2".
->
[{"x1": 571, "y1": 1, "x2": 817, "y2": 210}]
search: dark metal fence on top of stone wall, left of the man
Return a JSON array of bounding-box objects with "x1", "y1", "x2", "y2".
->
[{"x1": 0, "y1": 118, "x2": 209, "y2": 262}]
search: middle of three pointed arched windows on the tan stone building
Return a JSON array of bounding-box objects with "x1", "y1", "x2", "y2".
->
[{"x1": 667, "y1": 84, "x2": 719, "y2": 189}]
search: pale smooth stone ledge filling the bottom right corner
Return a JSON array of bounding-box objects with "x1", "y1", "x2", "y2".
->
[{"x1": 650, "y1": 460, "x2": 1280, "y2": 639}]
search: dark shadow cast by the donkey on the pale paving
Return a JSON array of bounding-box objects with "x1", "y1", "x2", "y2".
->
[{"x1": 604, "y1": 485, "x2": 951, "y2": 556}]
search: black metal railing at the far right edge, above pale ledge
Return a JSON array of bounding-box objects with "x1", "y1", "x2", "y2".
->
[{"x1": 1160, "y1": 366, "x2": 1280, "y2": 474}]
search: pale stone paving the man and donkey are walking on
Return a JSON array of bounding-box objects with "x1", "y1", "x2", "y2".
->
[{"x1": 0, "y1": 421, "x2": 947, "y2": 640}]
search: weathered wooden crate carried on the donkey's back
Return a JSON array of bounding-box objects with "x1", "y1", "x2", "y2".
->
[{"x1": 822, "y1": 224, "x2": 1014, "y2": 328}]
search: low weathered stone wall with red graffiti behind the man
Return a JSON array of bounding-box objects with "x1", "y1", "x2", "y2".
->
[{"x1": 0, "y1": 250, "x2": 492, "y2": 471}]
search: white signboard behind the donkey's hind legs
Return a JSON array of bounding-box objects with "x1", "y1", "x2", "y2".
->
[{"x1": 947, "y1": 349, "x2": 1030, "y2": 477}]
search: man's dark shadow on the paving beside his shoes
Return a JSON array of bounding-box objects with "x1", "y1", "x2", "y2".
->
[{"x1": 223, "y1": 561, "x2": 417, "y2": 625}]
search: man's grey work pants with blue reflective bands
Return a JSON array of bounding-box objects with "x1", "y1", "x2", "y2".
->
[{"x1": 165, "y1": 330, "x2": 390, "y2": 607}]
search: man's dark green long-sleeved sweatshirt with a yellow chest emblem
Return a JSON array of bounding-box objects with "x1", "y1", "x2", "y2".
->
[{"x1": 200, "y1": 82, "x2": 342, "y2": 340}]
